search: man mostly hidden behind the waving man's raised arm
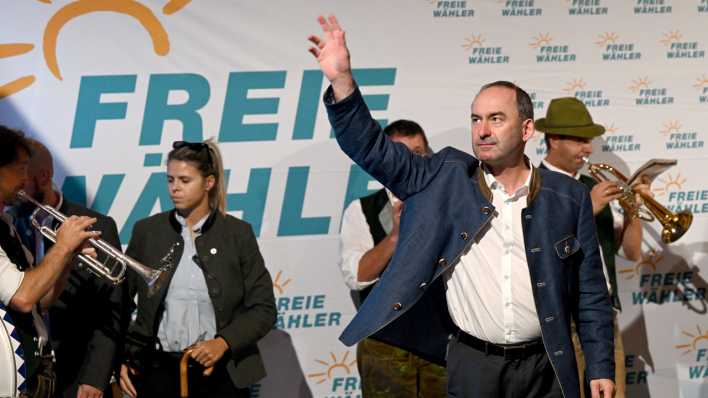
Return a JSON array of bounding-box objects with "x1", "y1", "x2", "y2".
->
[{"x1": 340, "y1": 120, "x2": 447, "y2": 398}]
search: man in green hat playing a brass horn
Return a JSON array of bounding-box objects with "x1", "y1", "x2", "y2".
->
[{"x1": 535, "y1": 97, "x2": 651, "y2": 398}]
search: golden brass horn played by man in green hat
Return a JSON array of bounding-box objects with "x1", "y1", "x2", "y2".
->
[{"x1": 583, "y1": 158, "x2": 693, "y2": 243}]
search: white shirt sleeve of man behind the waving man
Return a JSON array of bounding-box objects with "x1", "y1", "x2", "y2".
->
[{"x1": 339, "y1": 200, "x2": 378, "y2": 290}]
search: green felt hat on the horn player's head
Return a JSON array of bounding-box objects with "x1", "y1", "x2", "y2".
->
[{"x1": 535, "y1": 97, "x2": 605, "y2": 138}]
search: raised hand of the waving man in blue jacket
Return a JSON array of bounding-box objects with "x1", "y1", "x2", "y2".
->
[{"x1": 308, "y1": 15, "x2": 354, "y2": 101}]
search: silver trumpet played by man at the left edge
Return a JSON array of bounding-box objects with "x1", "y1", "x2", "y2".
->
[{"x1": 17, "y1": 191, "x2": 163, "y2": 291}]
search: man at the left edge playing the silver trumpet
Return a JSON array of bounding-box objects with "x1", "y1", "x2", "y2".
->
[{"x1": 0, "y1": 125, "x2": 100, "y2": 398}]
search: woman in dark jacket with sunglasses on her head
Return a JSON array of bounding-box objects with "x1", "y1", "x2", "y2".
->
[{"x1": 120, "y1": 140, "x2": 276, "y2": 398}]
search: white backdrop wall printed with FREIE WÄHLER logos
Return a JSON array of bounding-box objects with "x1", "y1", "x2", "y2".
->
[{"x1": 0, "y1": 0, "x2": 708, "y2": 398}]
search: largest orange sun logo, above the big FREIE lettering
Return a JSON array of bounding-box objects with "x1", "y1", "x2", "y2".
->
[{"x1": 0, "y1": 0, "x2": 192, "y2": 99}]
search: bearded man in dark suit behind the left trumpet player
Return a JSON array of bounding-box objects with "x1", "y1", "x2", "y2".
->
[{"x1": 13, "y1": 139, "x2": 123, "y2": 398}]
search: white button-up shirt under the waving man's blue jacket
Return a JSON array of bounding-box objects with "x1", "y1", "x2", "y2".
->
[{"x1": 445, "y1": 169, "x2": 541, "y2": 344}]
